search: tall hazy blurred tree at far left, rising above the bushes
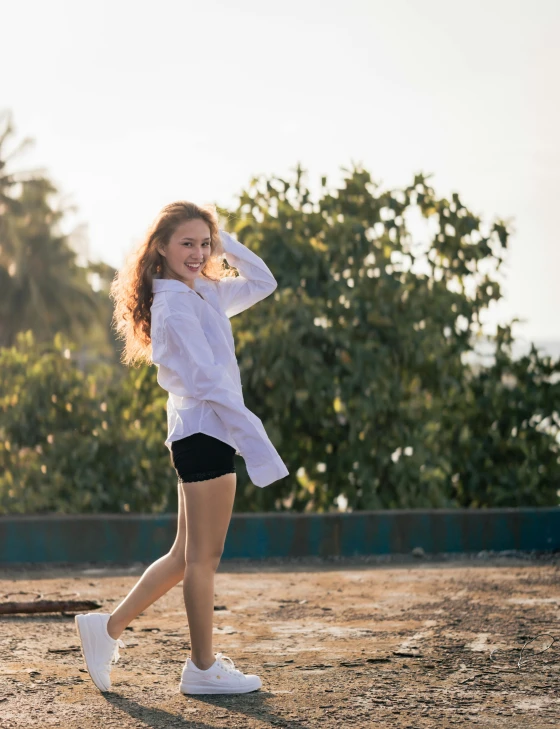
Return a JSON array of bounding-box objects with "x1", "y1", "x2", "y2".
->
[{"x1": 0, "y1": 111, "x2": 103, "y2": 346}]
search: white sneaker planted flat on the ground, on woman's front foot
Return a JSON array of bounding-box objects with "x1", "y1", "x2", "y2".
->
[{"x1": 179, "y1": 653, "x2": 262, "y2": 694}]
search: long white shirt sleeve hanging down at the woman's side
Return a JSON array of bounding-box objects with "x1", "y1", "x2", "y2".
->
[{"x1": 160, "y1": 313, "x2": 288, "y2": 479}]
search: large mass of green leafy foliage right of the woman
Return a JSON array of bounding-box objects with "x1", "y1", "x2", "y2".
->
[{"x1": 221, "y1": 166, "x2": 560, "y2": 511}]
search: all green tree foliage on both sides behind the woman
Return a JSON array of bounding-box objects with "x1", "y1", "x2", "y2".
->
[{"x1": 0, "y1": 144, "x2": 560, "y2": 513}]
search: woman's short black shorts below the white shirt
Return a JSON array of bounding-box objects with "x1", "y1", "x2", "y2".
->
[{"x1": 170, "y1": 433, "x2": 235, "y2": 482}]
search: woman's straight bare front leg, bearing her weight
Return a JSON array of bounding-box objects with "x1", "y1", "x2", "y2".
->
[{"x1": 183, "y1": 473, "x2": 237, "y2": 671}]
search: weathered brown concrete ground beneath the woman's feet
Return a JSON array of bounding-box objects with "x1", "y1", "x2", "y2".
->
[{"x1": 0, "y1": 553, "x2": 560, "y2": 729}]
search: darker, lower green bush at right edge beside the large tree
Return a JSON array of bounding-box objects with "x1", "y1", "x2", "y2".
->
[{"x1": 440, "y1": 326, "x2": 560, "y2": 507}]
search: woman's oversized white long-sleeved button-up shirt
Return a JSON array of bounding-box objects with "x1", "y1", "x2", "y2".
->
[{"x1": 151, "y1": 230, "x2": 289, "y2": 487}]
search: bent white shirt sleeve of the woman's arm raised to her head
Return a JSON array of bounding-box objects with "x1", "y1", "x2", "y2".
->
[{"x1": 217, "y1": 230, "x2": 278, "y2": 318}]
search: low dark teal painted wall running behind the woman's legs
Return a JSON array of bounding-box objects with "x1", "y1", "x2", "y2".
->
[{"x1": 0, "y1": 508, "x2": 560, "y2": 565}]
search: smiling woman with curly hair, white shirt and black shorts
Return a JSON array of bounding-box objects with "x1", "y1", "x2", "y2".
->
[{"x1": 76, "y1": 201, "x2": 289, "y2": 694}]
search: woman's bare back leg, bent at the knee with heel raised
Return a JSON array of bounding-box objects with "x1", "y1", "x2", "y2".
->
[{"x1": 107, "y1": 483, "x2": 187, "y2": 639}]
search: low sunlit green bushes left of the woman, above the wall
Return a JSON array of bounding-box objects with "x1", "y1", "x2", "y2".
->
[{"x1": 0, "y1": 332, "x2": 177, "y2": 514}]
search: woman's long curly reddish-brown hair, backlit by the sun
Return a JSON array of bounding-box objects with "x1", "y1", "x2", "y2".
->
[{"x1": 109, "y1": 200, "x2": 236, "y2": 366}]
